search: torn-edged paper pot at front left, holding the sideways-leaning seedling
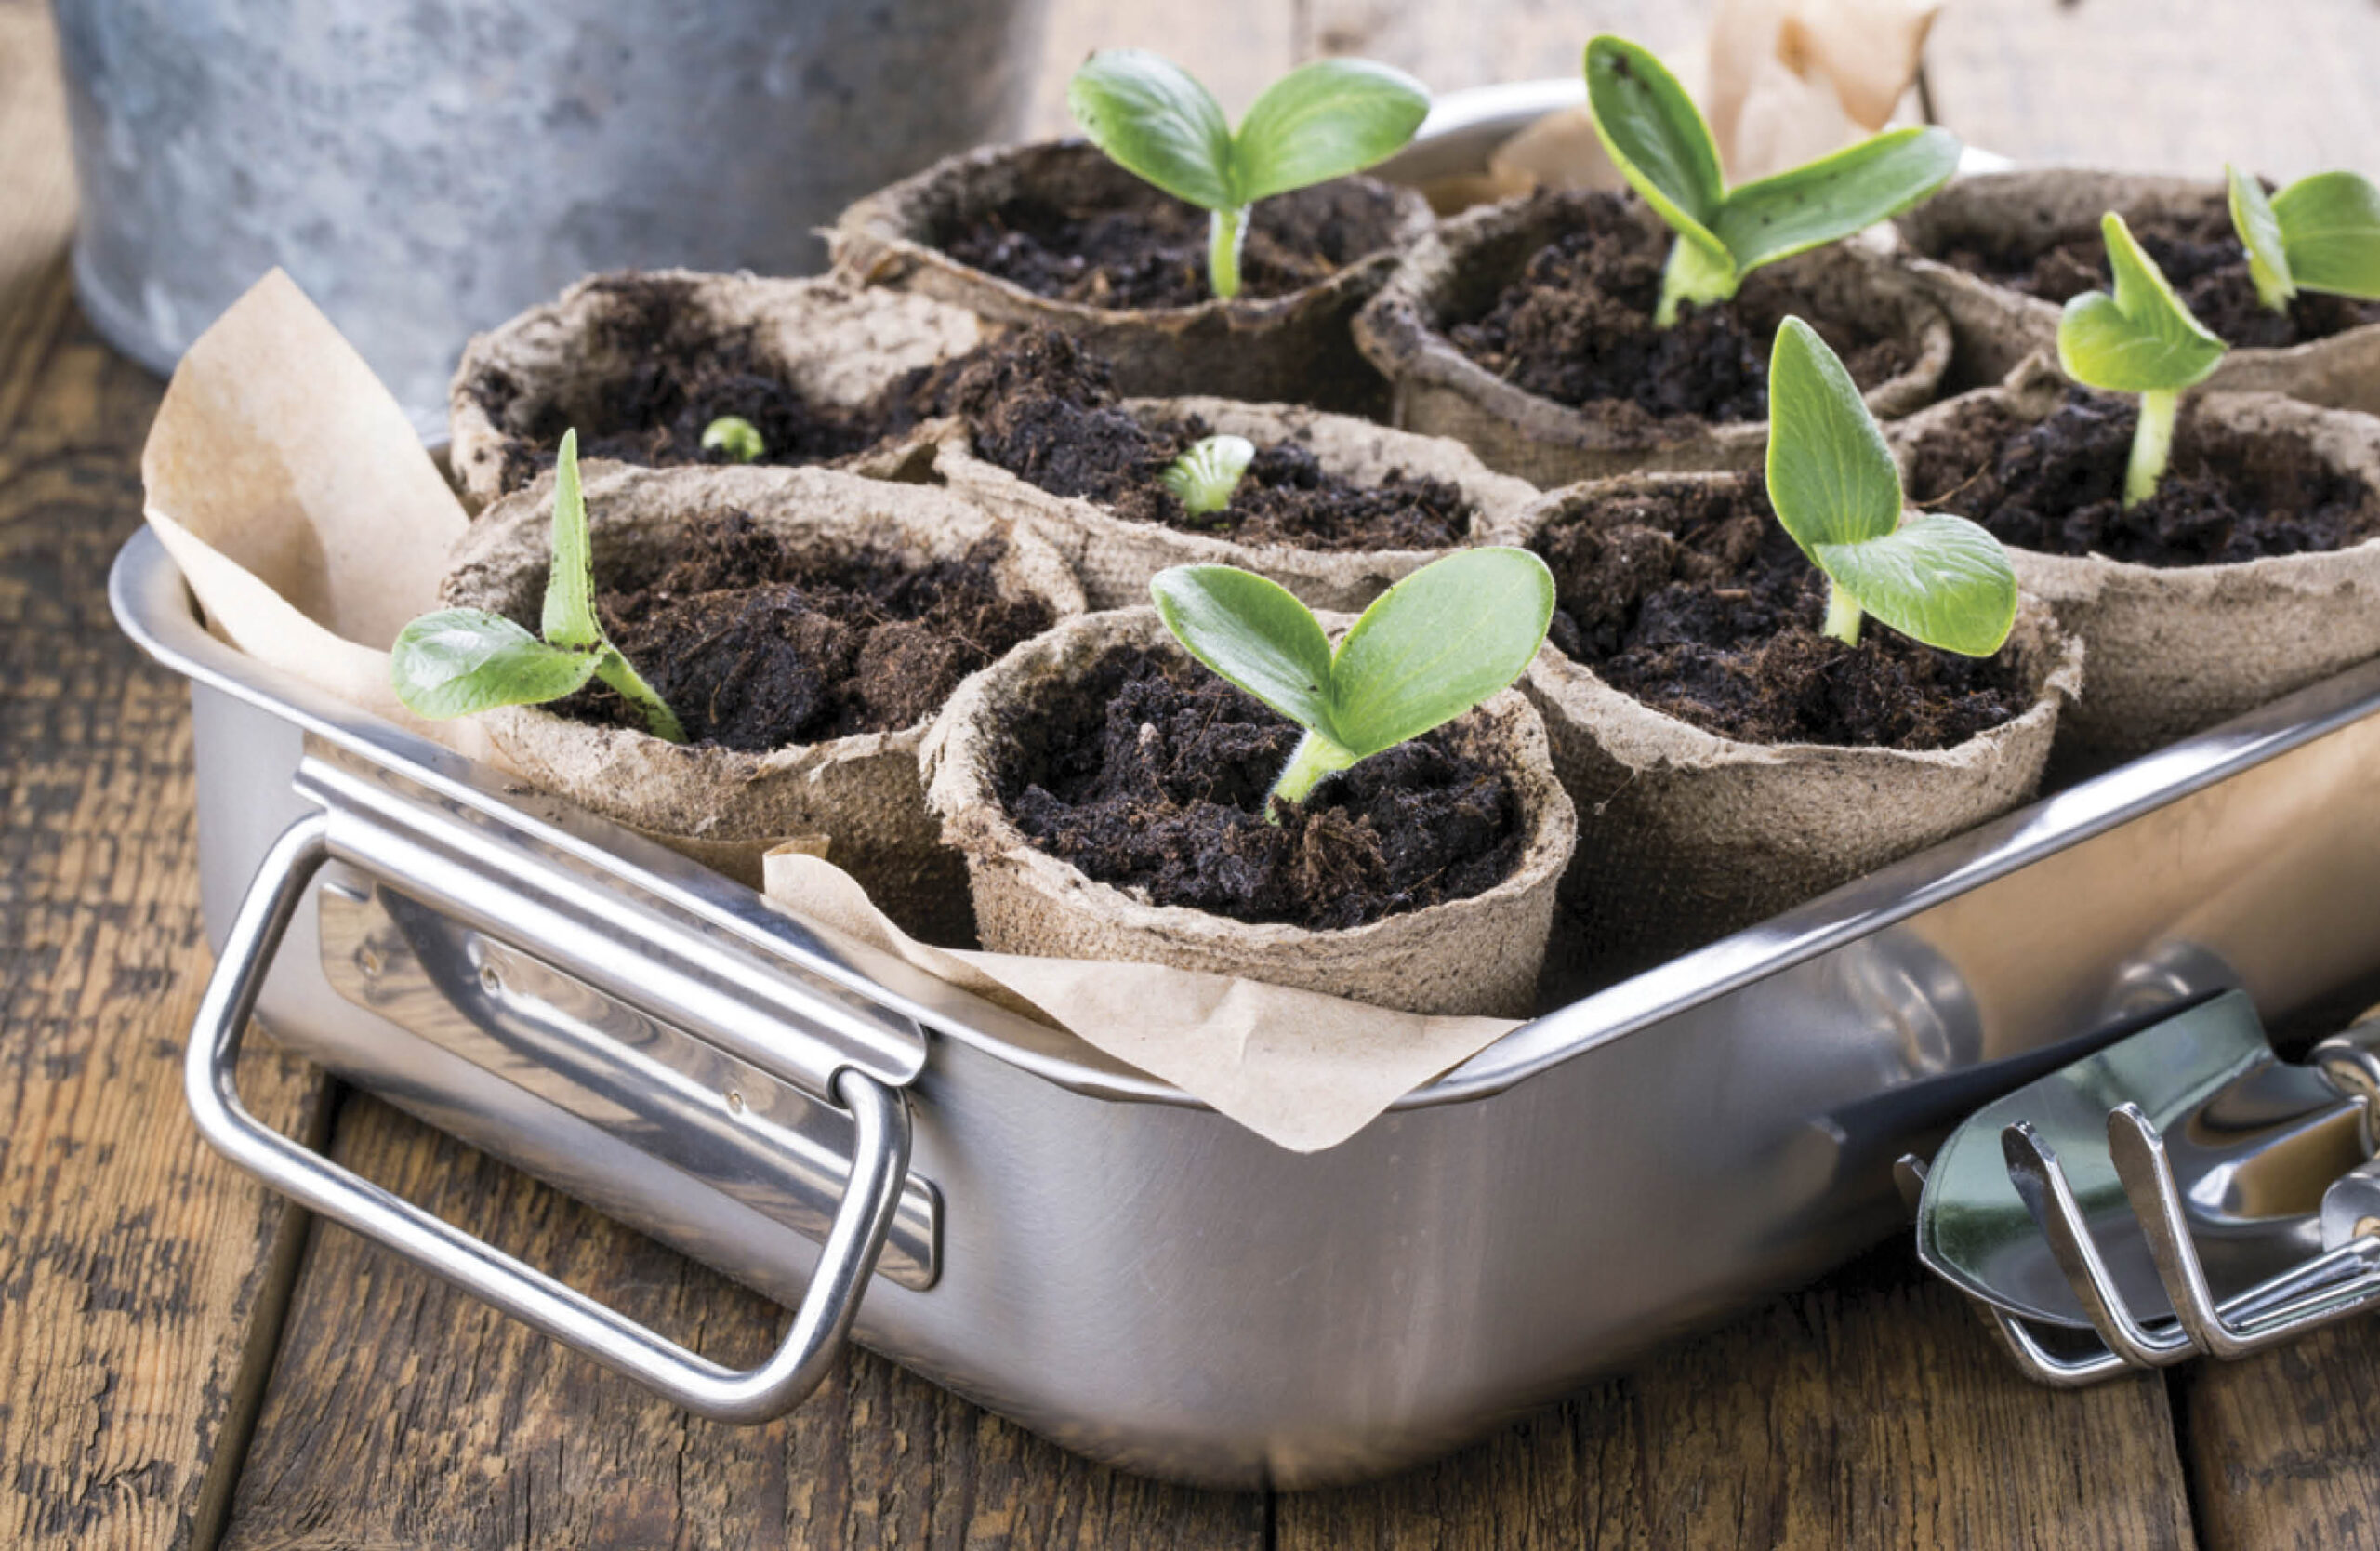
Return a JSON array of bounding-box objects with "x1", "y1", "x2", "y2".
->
[{"x1": 441, "y1": 464, "x2": 1083, "y2": 942}]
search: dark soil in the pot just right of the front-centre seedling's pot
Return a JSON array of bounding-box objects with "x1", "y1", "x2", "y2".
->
[{"x1": 1533, "y1": 473, "x2": 2032, "y2": 749}]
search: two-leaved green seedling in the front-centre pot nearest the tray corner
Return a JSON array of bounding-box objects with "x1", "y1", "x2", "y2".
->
[{"x1": 1149, "y1": 550, "x2": 1554, "y2": 818}]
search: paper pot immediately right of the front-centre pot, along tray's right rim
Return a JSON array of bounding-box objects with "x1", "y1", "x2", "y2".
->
[{"x1": 1500, "y1": 473, "x2": 2085, "y2": 973}]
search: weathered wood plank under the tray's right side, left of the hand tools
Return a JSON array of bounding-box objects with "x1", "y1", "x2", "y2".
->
[{"x1": 1278, "y1": 1247, "x2": 2189, "y2": 1551}]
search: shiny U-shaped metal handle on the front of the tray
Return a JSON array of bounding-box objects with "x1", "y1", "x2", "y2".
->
[{"x1": 183, "y1": 811, "x2": 909, "y2": 1423}]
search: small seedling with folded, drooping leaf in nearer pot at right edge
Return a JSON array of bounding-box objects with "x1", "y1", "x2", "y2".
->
[{"x1": 2058, "y1": 209, "x2": 2226, "y2": 507}]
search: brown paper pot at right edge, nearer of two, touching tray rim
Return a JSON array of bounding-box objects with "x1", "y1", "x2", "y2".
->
[{"x1": 1887, "y1": 359, "x2": 2380, "y2": 768}]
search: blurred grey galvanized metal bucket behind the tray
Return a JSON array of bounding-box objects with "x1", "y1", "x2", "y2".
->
[{"x1": 57, "y1": 0, "x2": 1045, "y2": 433}]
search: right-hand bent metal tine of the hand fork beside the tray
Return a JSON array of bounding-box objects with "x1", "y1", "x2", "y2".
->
[{"x1": 2107, "y1": 1104, "x2": 2380, "y2": 1359}]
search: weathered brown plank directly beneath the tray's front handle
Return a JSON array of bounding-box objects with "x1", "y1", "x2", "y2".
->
[{"x1": 226, "y1": 1096, "x2": 1263, "y2": 1551}]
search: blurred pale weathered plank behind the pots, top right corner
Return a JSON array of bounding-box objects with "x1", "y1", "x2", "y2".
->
[{"x1": 1925, "y1": 0, "x2": 2380, "y2": 179}]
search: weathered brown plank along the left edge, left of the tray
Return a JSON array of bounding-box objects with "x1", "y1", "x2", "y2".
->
[{"x1": 0, "y1": 254, "x2": 328, "y2": 1546}]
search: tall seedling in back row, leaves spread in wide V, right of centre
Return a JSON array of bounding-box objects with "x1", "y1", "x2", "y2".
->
[{"x1": 1588, "y1": 33, "x2": 1959, "y2": 328}]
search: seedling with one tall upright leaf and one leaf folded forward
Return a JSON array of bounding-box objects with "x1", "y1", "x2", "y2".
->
[{"x1": 1768, "y1": 319, "x2": 2016, "y2": 656}]
